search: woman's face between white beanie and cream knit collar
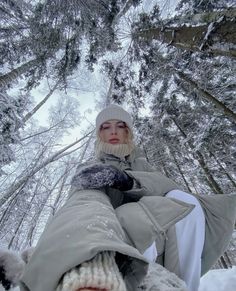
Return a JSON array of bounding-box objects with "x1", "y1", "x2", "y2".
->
[{"x1": 99, "y1": 119, "x2": 128, "y2": 144}]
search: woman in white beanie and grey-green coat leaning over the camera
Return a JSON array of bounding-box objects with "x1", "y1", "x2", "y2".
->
[{"x1": 18, "y1": 105, "x2": 236, "y2": 291}]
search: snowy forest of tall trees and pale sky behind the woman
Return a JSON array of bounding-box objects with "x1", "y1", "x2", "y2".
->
[{"x1": 0, "y1": 0, "x2": 236, "y2": 274}]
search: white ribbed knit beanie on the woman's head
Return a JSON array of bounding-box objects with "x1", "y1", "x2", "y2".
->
[{"x1": 96, "y1": 104, "x2": 132, "y2": 133}]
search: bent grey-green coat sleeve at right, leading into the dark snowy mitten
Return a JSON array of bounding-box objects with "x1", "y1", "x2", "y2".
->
[{"x1": 125, "y1": 159, "x2": 182, "y2": 198}]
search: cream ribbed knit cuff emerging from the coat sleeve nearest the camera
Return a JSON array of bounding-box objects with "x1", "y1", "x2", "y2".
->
[{"x1": 56, "y1": 252, "x2": 127, "y2": 291}]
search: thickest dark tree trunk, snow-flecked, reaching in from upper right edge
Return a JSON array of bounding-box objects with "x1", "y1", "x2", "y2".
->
[{"x1": 132, "y1": 10, "x2": 236, "y2": 57}]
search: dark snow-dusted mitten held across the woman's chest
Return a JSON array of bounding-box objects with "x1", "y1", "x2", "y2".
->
[{"x1": 71, "y1": 164, "x2": 133, "y2": 191}]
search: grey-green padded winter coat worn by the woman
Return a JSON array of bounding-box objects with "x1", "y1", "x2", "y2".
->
[{"x1": 21, "y1": 151, "x2": 236, "y2": 291}]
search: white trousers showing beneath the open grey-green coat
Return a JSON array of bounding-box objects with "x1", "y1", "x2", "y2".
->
[{"x1": 143, "y1": 190, "x2": 205, "y2": 291}]
